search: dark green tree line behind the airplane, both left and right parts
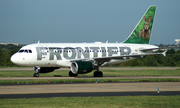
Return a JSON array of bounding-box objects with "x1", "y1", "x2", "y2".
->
[{"x1": 0, "y1": 44, "x2": 180, "y2": 67}]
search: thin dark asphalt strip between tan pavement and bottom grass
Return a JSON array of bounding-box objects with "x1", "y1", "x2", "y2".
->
[{"x1": 0, "y1": 91, "x2": 180, "y2": 99}]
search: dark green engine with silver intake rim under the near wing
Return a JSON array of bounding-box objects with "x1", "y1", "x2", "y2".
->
[{"x1": 71, "y1": 61, "x2": 94, "y2": 74}]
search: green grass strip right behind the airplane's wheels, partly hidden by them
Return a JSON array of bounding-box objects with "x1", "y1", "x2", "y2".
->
[{"x1": 0, "y1": 69, "x2": 180, "y2": 77}]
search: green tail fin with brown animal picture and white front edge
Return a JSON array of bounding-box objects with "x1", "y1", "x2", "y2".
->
[{"x1": 123, "y1": 6, "x2": 156, "y2": 44}]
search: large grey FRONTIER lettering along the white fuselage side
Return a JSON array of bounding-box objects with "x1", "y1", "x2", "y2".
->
[{"x1": 36, "y1": 47, "x2": 131, "y2": 60}]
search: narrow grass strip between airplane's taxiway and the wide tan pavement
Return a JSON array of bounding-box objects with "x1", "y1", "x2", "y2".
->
[{"x1": 0, "y1": 78, "x2": 180, "y2": 85}]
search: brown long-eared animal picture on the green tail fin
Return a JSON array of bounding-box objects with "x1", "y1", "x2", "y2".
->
[{"x1": 138, "y1": 16, "x2": 151, "y2": 39}]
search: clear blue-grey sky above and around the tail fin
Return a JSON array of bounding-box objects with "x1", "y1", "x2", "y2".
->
[{"x1": 0, "y1": 0, "x2": 180, "y2": 44}]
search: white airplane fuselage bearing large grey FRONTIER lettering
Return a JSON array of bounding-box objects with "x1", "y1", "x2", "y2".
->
[{"x1": 11, "y1": 43, "x2": 158, "y2": 67}]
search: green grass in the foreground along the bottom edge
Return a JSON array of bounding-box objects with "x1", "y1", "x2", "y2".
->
[{"x1": 0, "y1": 96, "x2": 180, "y2": 108}]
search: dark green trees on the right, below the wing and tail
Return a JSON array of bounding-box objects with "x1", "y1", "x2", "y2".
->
[{"x1": 114, "y1": 48, "x2": 180, "y2": 67}]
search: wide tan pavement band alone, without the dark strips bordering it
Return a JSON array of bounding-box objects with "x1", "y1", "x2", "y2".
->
[{"x1": 0, "y1": 82, "x2": 180, "y2": 94}]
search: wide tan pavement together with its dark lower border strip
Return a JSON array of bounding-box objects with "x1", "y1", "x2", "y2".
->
[{"x1": 0, "y1": 82, "x2": 180, "y2": 98}]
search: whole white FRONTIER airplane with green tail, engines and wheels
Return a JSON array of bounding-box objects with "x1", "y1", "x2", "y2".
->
[{"x1": 11, "y1": 6, "x2": 165, "y2": 77}]
